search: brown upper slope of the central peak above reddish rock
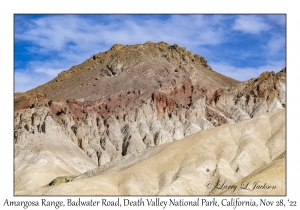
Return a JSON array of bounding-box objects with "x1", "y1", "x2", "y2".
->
[{"x1": 24, "y1": 42, "x2": 237, "y2": 101}]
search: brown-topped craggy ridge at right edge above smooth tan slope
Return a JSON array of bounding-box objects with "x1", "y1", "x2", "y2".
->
[{"x1": 214, "y1": 68, "x2": 286, "y2": 121}]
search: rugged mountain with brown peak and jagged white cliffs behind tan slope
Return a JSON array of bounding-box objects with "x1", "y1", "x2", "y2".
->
[{"x1": 14, "y1": 42, "x2": 286, "y2": 194}]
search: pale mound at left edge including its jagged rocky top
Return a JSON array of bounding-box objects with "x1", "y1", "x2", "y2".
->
[{"x1": 14, "y1": 107, "x2": 97, "y2": 191}]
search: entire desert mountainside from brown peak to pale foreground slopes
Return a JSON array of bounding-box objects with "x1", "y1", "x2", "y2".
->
[{"x1": 14, "y1": 42, "x2": 286, "y2": 195}]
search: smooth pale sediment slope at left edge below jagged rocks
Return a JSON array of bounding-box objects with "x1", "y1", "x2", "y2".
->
[{"x1": 14, "y1": 117, "x2": 97, "y2": 194}]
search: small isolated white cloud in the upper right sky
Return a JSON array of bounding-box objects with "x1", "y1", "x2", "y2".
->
[{"x1": 232, "y1": 15, "x2": 270, "y2": 34}]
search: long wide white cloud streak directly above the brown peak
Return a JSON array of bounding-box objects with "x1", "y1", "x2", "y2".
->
[{"x1": 16, "y1": 15, "x2": 223, "y2": 55}]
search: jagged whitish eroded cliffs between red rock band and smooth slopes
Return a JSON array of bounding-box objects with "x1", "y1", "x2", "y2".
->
[{"x1": 15, "y1": 94, "x2": 213, "y2": 165}]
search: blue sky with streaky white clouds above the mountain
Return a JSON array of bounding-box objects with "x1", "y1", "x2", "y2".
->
[{"x1": 14, "y1": 15, "x2": 286, "y2": 92}]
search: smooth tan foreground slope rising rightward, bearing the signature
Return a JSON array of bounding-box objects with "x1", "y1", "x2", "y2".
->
[{"x1": 19, "y1": 109, "x2": 286, "y2": 195}]
